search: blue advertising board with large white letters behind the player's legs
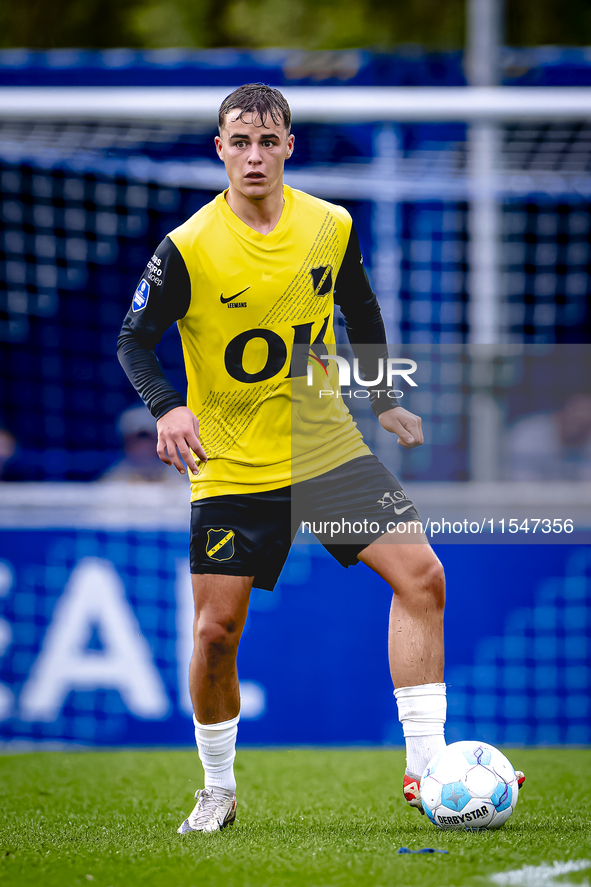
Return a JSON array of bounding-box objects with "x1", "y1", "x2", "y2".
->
[{"x1": 0, "y1": 528, "x2": 591, "y2": 746}]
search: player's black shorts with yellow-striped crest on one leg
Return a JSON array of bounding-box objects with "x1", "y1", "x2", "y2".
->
[{"x1": 190, "y1": 456, "x2": 420, "y2": 591}]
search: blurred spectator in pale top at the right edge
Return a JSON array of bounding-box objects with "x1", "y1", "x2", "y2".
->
[{"x1": 506, "y1": 394, "x2": 591, "y2": 480}]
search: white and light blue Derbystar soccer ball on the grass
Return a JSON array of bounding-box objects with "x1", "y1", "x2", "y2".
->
[{"x1": 421, "y1": 741, "x2": 519, "y2": 832}]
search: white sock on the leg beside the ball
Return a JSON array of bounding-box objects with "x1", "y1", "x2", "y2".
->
[{"x1": 394, "y1": 684, "x2": 447, "y2": 777}]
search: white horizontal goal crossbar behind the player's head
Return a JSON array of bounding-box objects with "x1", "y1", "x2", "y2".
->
[{"x1": 0, "y1": 86, "x2": 591, "y2": 123}]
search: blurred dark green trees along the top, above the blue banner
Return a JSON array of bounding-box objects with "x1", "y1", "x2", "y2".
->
[{"x1": 0, "y1": 0, "x2": 591, "y2": 50}]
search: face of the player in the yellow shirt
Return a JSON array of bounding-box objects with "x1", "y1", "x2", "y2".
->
[{"x1": 215, "y1": 108, "x2": 294, "y2": 200}]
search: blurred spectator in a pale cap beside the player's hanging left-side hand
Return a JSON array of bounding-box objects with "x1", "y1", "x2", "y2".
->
[{"x1": 100, "y1": 406, "x2": 187, "y2": 483}]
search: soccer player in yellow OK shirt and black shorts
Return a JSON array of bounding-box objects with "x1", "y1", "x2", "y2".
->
[{"x1": 118, "y1": 84, "x2": 446, "y2": 833}]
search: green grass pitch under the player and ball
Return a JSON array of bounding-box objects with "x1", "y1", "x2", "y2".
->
[{"x1": 0, "y1": 749, "x2": 591, "y2": 887}]
